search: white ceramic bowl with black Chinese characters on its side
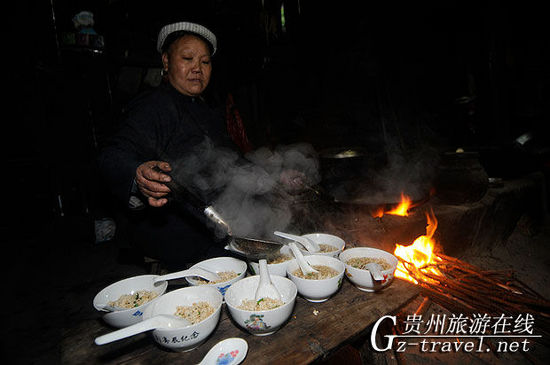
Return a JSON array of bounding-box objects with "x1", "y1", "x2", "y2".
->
[{"x1": 143, "y1": 285, "x2": 223, "y2": 351}]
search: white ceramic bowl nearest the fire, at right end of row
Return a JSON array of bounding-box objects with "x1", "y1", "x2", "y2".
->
[{"x1": 339, "y1": 247, "x2": 399, "y2": 292}]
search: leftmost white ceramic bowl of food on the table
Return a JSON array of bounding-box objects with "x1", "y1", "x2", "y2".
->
[{"x1": 93, "y1": 275, "x2": 168, "y2": 328}]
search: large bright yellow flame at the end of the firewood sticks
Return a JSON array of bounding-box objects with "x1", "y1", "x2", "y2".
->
[{"x1": 394, "y1": 211, "x2": 441, "y2": 284}]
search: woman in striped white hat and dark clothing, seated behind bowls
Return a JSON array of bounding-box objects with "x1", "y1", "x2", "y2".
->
[{"x1": 98, "y1": 22, "x2": 235, "y2": 267}]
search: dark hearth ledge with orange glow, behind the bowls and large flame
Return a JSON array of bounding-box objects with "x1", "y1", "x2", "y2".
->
[{"x1": 296, "y1": 174, "x2": 545, "y2": 257}]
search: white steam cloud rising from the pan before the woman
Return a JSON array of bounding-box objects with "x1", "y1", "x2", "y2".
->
[{"x1": 173, "y1": 139, "x2": 320, "y2": 239}]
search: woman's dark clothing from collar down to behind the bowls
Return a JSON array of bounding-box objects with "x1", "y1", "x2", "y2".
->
[{"x1": 98, "y1": 82, "x2": 238, "y2": 266}]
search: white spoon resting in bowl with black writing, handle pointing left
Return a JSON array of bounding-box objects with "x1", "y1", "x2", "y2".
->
[{"x1": 95, "y1": 314, "x2": 191, "y2": 345}]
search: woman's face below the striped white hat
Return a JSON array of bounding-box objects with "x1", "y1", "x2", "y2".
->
[{"x1": 162, "y1": 35, "x2": 212, "y2": 96}]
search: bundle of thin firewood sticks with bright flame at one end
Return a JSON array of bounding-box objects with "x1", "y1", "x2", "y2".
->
[{"x1": 394, "y1": 206, "x2": 550, "y2": 337}]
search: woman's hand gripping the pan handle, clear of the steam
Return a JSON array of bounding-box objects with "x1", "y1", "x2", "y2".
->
[{"x1": 136, "y1": 161, "x2": 172, "y2": 208}]
